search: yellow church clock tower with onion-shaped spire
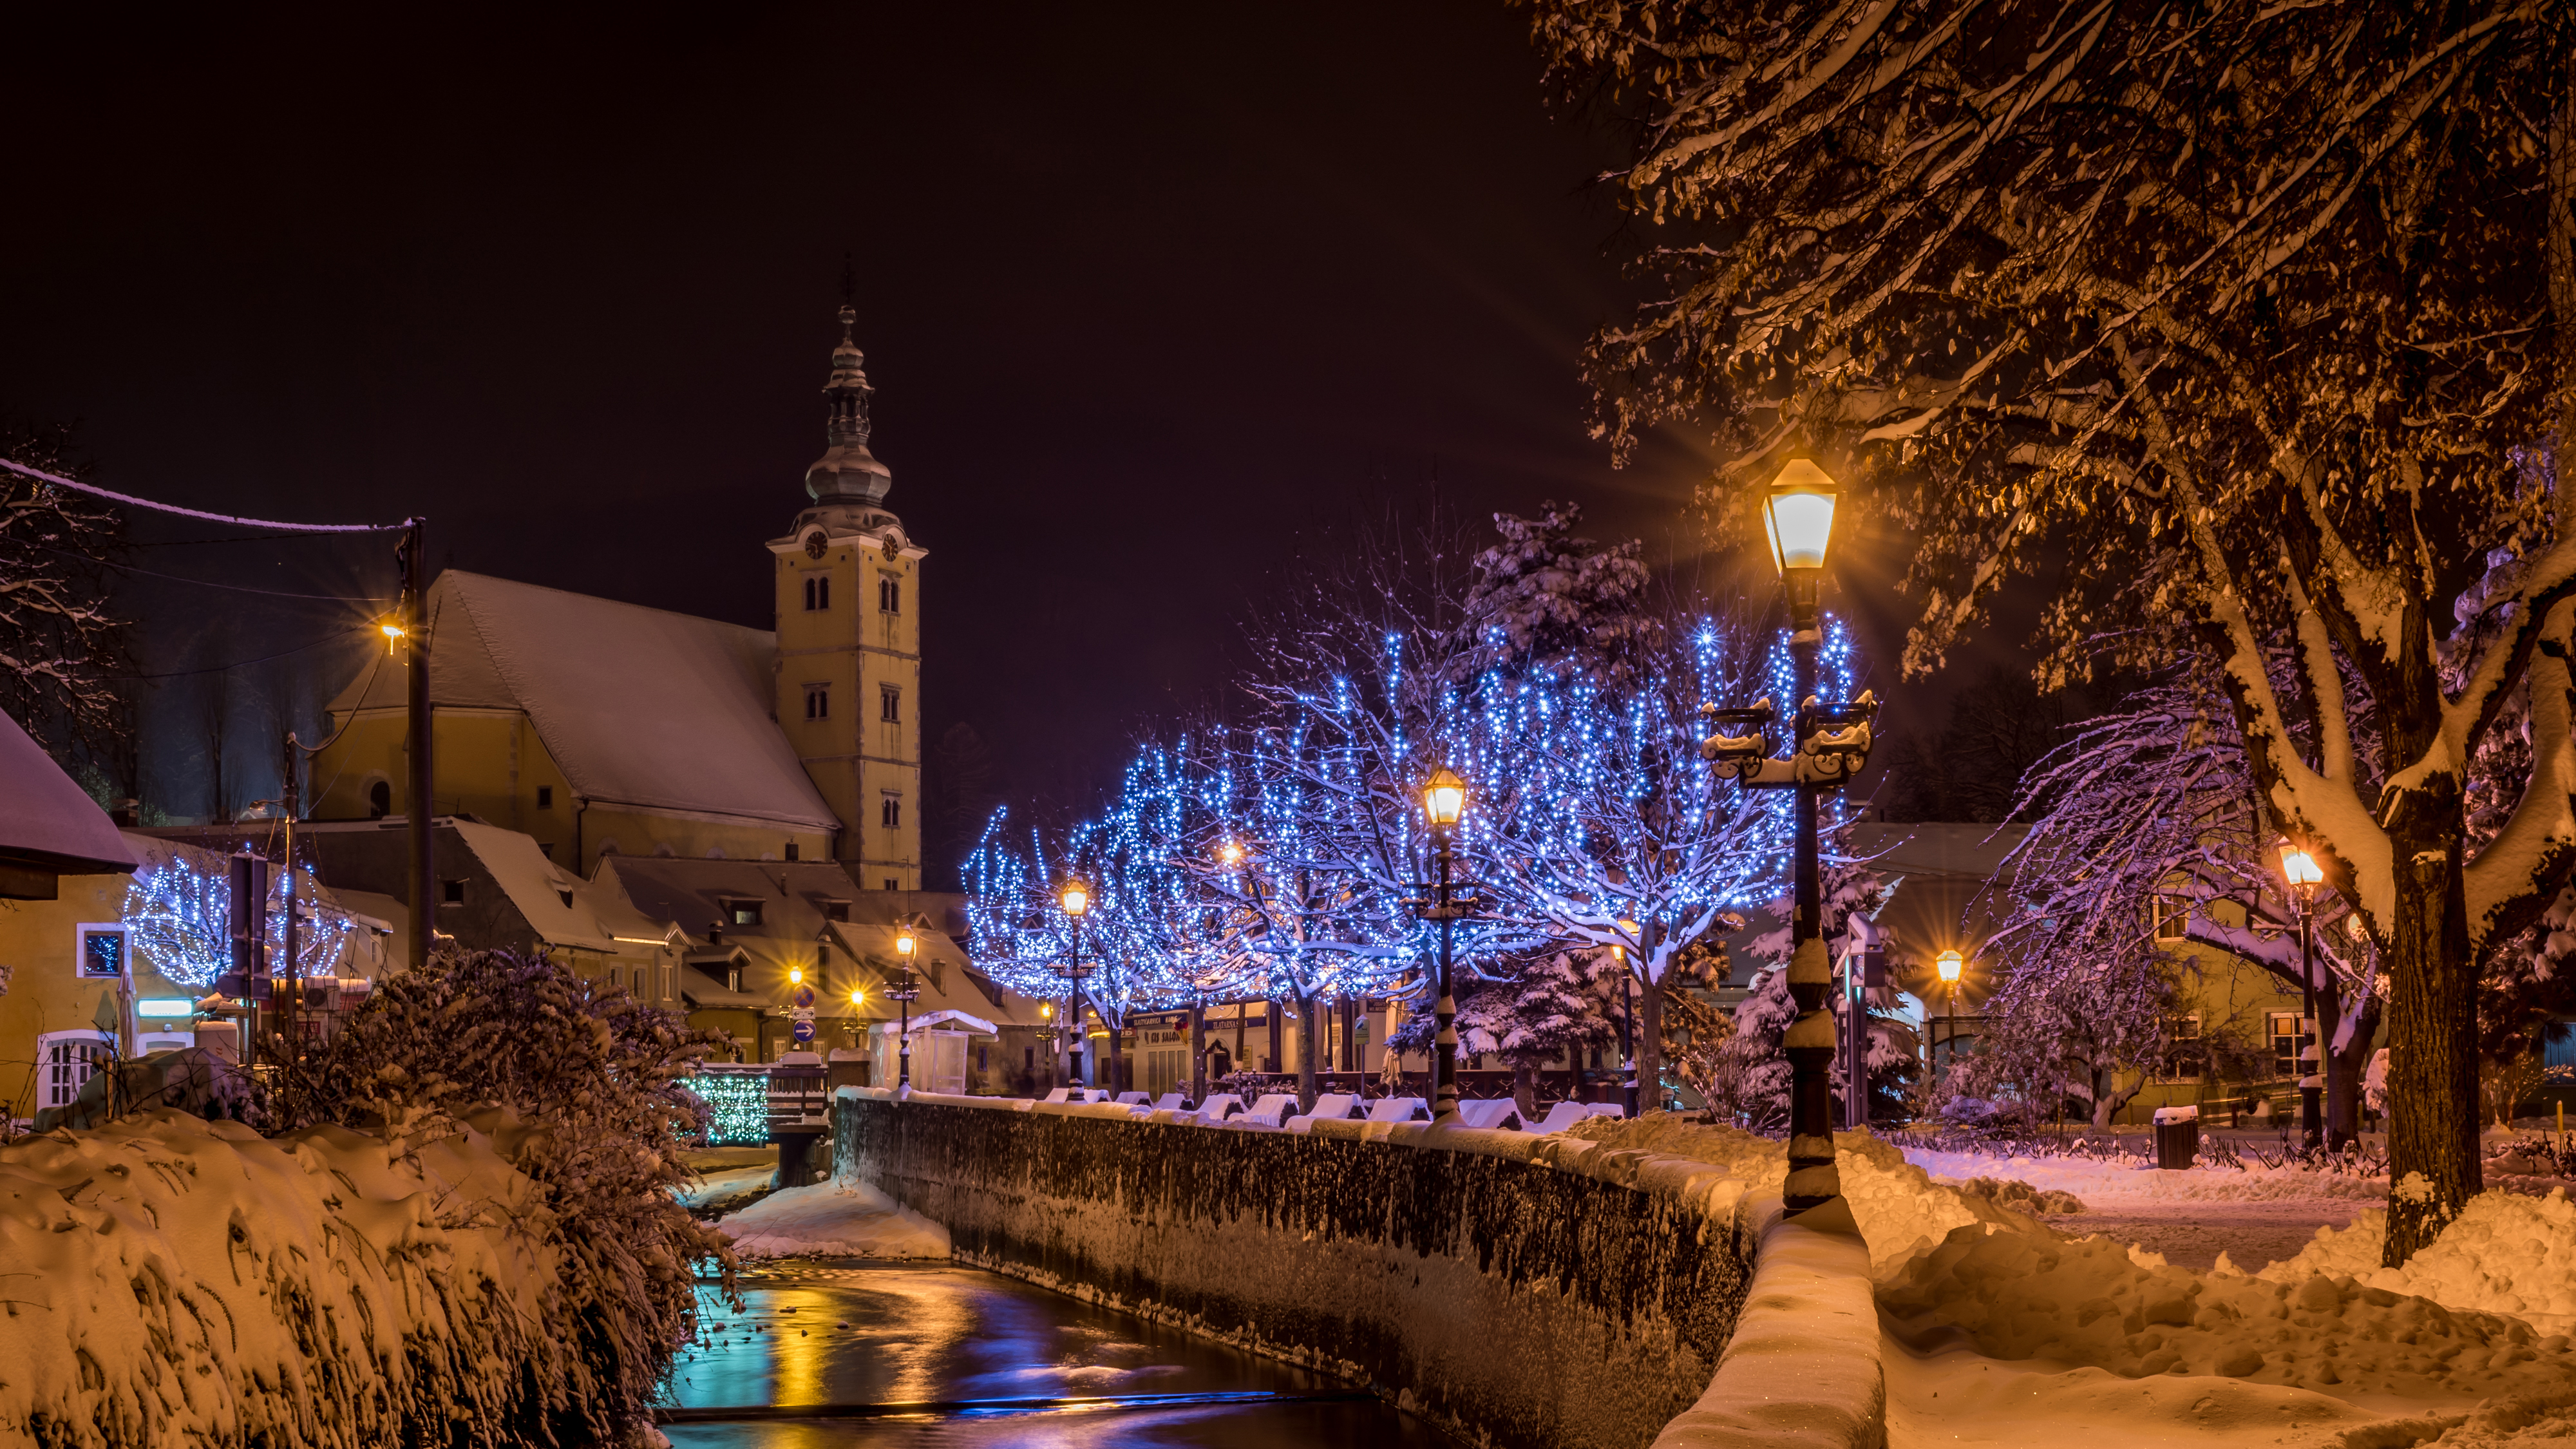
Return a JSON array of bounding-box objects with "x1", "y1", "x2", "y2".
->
[{"x1": 770, "y1": 307, "x2": 927, "y2": 889}]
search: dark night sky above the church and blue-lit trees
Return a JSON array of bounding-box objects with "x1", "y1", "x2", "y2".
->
[{"x1": 0, "y1": 0, "x2": 1947, "y2": 851}]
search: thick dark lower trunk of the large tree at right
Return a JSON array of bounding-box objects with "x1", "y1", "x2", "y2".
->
[{"x1": 2380, "y1": 830, "x2": 2483, "y2": 1269}]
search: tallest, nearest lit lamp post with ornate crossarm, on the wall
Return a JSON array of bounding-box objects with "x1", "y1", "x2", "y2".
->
[{"x1": 1700, "y1": 459, "x2": 1878, "y2": 1212}]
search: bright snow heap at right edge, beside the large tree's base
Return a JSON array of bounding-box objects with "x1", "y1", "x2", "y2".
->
[{"x1": 2259, "y1": 1189, "x2": 2576, "y2": 1333}]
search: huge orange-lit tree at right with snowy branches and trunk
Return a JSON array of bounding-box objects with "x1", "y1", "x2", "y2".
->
[{"x1": 1535, "y1": 0, "x2": 2576, "y2": 1264}]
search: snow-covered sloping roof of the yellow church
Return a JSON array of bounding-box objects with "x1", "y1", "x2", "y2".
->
[{"x1": 332, "y1": 570, "x2": 840, "y2": 830}]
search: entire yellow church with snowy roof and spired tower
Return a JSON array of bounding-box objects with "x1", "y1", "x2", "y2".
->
[{"x1": 312, "y1": 307, "x2": 925, "y2": 889}]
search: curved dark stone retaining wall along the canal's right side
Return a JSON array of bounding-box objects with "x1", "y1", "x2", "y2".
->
[{"x1": 832, "y1": 1088, "x2": 1754, "y2": 1449}]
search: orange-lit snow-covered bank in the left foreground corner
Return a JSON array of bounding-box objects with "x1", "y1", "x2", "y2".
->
[{"x1": 0, "y1": 1112, "x2": 577, "y2": 1449}]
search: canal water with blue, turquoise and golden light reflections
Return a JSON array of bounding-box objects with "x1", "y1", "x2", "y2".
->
[{"x1": 662, "y1": 1261, "x2": 1455, "y2": 1449}]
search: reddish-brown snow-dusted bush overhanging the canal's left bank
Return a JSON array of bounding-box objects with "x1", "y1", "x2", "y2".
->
[{"x1": 278, "y1": 951, "x2": 734, "y2": 1439}]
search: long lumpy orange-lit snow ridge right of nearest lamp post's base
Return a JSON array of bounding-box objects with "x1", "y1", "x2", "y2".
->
[{"x1": 1878, "y1": 1225, "x2": 2576, "y2": 1400}]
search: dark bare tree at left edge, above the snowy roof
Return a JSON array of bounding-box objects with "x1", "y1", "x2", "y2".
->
[{"x1": 0, "y1": 426, "x2": 134, "y2": 768}]
